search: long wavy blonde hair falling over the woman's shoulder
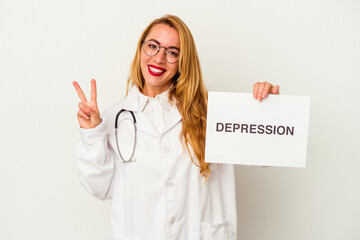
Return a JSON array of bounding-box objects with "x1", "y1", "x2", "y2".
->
[{"x1": 127, "y1": 15, "x2": 210, "y2": 180}]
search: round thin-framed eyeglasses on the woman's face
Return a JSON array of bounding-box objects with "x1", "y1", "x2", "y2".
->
[{"x1": 143, "y1": 40, "x2": 180, "y2": 64}]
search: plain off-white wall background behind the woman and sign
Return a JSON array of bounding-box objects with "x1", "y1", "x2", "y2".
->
[{"x1": 0, "y1": 0, "x2": 360, "y2": 240}]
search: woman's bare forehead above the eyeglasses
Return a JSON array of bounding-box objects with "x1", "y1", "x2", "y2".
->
[{"x1": 145, "y1": 23, "x2": 180, "y2": 48}]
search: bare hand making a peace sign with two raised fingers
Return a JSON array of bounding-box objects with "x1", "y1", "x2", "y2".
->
[{"x1": 73, "y1": 79, "x2": 101, "y2": 129}]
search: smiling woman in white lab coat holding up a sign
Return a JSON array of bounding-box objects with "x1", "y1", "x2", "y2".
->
[{"x1": 74, "y1": 15, "x2": 278, "y2": 240}]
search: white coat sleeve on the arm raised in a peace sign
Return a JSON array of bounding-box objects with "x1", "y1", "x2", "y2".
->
[{"x1": 76, "y1": 119, "x2": 115, "y2": 200}]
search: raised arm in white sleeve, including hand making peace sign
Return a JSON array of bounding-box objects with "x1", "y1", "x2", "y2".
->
[{"x1": 73, "y1": 79, "x2": 115, "y2": 200}]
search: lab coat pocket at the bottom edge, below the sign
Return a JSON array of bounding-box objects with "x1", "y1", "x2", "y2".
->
[{"x1": 200, "y1": 220, "x2": 232, "y2": 240}]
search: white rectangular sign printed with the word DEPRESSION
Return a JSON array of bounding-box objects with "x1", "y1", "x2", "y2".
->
[{"x1": 205, "y1": 92, "x2": 310, "y2": 167}]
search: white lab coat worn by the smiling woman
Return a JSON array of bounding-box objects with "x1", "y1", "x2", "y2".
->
[{"x1": 76, "y1": 87, "x2": 237, "y2": 240}]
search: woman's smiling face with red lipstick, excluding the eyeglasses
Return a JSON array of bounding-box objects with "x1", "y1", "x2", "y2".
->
[{"x1": 140, "y1": 24, "x2": 180, "y2": 97}]
